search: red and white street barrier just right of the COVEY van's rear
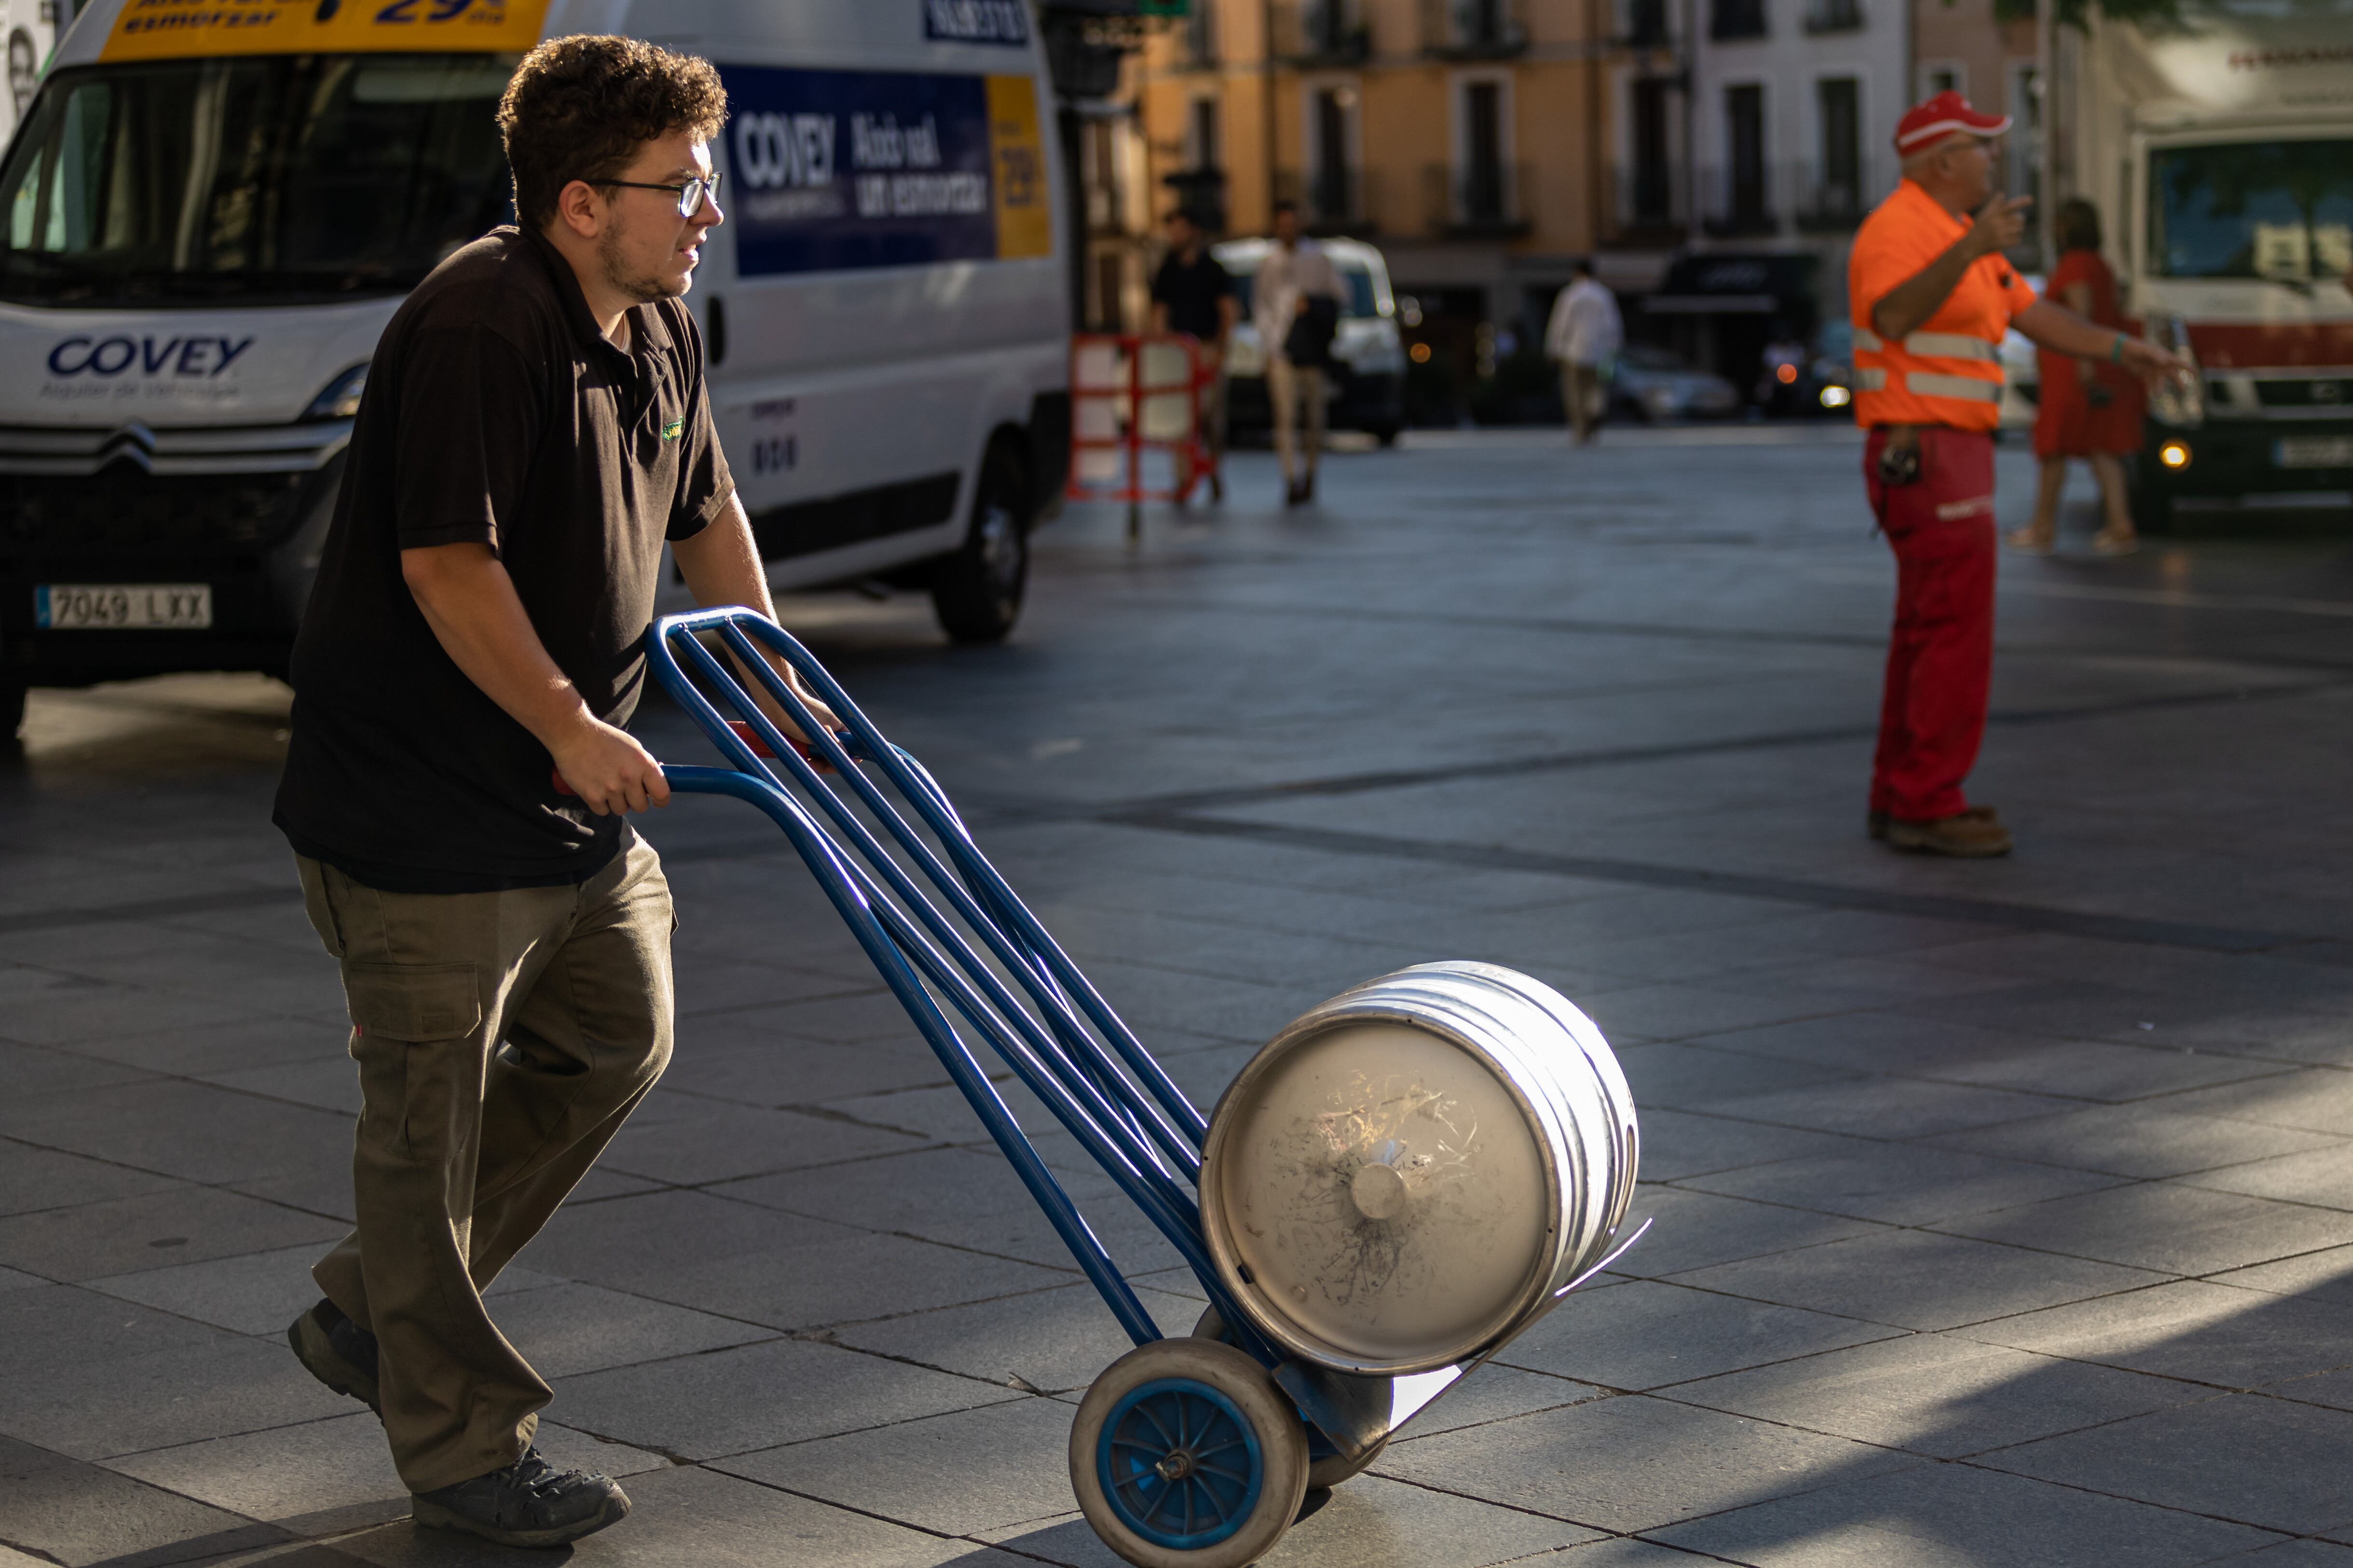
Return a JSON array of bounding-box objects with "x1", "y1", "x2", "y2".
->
[{"x1": 1068, "y1": 332, "x2": 1217, "y2": 534}]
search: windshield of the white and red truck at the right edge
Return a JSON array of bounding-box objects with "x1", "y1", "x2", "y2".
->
[{"x1": 2148, "y1": 141, "x2": 2353, "y2": 283}]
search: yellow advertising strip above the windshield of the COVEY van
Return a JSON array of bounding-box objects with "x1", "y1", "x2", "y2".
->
[{"x1": 99, "y1": 0, "x2": 548, "y2": 59}]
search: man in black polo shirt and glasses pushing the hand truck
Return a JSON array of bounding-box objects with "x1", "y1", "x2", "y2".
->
[{"x1": 275, "y1": 38, "x2": 831, "y2": 1547}]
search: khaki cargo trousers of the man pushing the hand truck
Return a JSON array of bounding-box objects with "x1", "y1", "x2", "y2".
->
[{"x1": 297, "y1": 841, "x2": 673, "y2": 1493}]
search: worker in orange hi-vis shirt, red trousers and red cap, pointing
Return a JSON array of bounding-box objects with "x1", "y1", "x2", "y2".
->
[{"x1": 1847, "y1": 92, "x2": 2189, "y2": 857}]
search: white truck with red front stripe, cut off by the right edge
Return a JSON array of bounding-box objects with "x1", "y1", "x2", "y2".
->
[{"x1": 2056, "y1": 0, "x2": 2353, "y2": 527}]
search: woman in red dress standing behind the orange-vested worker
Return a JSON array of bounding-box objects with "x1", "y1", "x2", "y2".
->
[{"x1": 2010, "y1": 198, "x2": 2144, "y2": 556}]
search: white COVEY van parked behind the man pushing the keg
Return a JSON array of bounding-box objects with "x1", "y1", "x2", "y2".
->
[{"x1": 0, "y1": 0, "x2": 1070, "y2": 735}]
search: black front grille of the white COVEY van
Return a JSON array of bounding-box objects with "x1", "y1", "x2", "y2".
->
[{"x1": 0, "y1": 462, "x2": 308, "y2": 558}]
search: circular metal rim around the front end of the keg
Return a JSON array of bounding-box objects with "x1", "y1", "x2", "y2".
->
[{"x1": 1198, "y1": 984, "x2": 1565, "y2": 1377}]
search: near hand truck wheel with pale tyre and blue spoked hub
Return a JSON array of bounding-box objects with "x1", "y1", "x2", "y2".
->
[{"x1": 1070, "y1": 1340, "x2": 1308, "y2": 1568}]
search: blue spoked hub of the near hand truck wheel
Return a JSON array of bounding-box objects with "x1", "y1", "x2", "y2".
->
[{"x1": 1094, "y1": 1377, "x2": 1266, "y2": 1552}]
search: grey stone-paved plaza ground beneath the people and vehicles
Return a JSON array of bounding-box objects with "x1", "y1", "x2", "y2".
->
[{"x1": 0, "y1": 426, "x2": 2353, "y2": 1568}]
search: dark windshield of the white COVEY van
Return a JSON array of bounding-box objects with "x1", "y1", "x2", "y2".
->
[{"x1": 0, "y1": 54, "x2": 515, "y2": 306}]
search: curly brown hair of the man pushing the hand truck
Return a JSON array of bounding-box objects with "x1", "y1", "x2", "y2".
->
[{"x1": 499, "y1": 35, "x2": 727, "y2": 228}]
